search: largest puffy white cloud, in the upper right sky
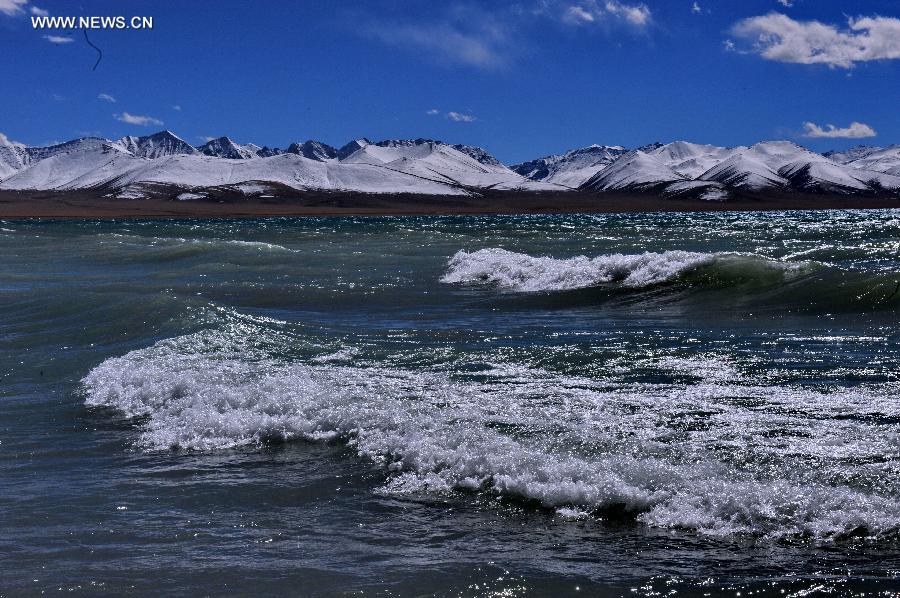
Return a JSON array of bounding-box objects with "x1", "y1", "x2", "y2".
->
[{"x1": 732, "y1": 13, "x2": 900, "y2": 69}]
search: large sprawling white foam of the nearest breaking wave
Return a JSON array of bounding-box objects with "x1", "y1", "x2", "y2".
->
[{"x1": 82, "y1": 330, "x2": 900, "y2": 541}]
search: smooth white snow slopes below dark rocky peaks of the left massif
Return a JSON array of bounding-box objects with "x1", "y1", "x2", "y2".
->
[{"x1": 0, "y1": 139, "x2": 546, "y2": 195}]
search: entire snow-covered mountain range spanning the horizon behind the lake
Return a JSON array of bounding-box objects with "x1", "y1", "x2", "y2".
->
[{"x1": 0, "y1": 131, "x2": 900, "y2": 200}]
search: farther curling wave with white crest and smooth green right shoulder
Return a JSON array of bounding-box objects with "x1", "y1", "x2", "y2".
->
[{"x1": 441, "y1": 248, "x2": 900, "y2": 311}]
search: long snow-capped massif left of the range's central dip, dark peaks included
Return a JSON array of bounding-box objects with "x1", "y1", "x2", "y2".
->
[{"x1": 0, "y1": 131, "x2": 560, "y2": 197}]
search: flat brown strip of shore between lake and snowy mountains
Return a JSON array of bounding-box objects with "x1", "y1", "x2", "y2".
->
[{"x1": 0, "y1": 191, "x2": 900, "y2": 220}]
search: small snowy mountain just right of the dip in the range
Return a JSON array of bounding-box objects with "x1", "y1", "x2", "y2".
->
[{"x1": 510, "y1": 145, "x2": 628, "y2": 188}]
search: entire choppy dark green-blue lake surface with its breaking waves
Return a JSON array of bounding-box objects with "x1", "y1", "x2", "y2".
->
[{"x1": 0, "y1": 211, "x2": 900, "y2": 596}]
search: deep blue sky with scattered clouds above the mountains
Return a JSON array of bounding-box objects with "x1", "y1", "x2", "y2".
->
[{"x1": 0, "y1": 0, "x2": 900, "y2": 163}]
